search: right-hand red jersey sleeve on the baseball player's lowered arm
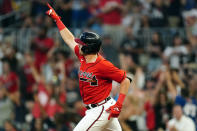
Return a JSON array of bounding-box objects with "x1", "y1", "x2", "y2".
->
[{"x1": 99, "y1": 60, "x2": 126, "y2": 83}]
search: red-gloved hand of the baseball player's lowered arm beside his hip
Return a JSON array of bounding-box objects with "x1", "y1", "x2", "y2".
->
[{"x1": 106, "y1": 102, "x2": 122, "y2": 120}]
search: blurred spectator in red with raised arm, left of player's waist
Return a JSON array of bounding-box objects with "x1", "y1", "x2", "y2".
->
[{"x1": 28, "y1": 58, "x2": 66, "y2": 119}]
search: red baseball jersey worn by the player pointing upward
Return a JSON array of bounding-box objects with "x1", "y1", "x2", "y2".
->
[{"x1": 75, "y1": 45, "x2": 126, "y2": 104}]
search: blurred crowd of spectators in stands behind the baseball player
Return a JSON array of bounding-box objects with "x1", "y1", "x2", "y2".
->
[{"x1": 0, "y1": 0, "x2": 197, "y2": 131}]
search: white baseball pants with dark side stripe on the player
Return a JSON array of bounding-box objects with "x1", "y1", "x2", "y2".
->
[{"x1": 74, "y1": 98, "x2": 122, "y2": 131}]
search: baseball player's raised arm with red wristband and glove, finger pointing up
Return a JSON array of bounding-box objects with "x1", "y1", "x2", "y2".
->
[{"x1": 46, "y1": 3, "x2": 77, "y2": 51}]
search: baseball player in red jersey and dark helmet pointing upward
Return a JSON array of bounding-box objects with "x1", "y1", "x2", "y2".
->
[{"x1": 46, "y1": 4, "x2": 132, "y2": 131}]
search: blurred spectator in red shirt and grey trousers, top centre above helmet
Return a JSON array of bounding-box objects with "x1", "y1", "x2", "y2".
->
[{"x1": 99, "y1": 0, "x2": 126, "y2": 48}]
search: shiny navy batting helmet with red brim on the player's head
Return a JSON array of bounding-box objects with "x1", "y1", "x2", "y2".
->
[{"x1": 75, "y1": 32, "x2": 102, "y2": 54}]
